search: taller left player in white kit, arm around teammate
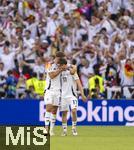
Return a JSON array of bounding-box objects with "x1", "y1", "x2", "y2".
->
[{"x1": 44, "y1": 52, "x2": 64, "y2": 134}]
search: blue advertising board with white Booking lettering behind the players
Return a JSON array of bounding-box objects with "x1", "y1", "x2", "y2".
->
[{"x1": 0, "y1": 99, "x2": 134, "y2": 126}]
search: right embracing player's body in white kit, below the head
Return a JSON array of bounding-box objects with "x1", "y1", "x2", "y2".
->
[{"x1": 60, "y1": 70, "x2": 86, "y2": 136}]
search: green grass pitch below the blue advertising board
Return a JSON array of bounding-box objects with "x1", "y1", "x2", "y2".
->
[{"x1": 50, "y1": 127, "x2": 134, "y2": 150}]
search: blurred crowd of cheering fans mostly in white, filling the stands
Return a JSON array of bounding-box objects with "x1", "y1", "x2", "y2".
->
[{"x1": 0, "y1": 0, "x2": 134, "y2": 98}]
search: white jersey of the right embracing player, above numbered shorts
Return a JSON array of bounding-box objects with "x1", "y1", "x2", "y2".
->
[{"x1": 61, "y1": 70, "x2": 79, "y2": 99}]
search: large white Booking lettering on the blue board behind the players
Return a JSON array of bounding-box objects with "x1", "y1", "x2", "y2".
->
[{"x1": 40, "y1": 100, "x2": 134, "y2": 126}]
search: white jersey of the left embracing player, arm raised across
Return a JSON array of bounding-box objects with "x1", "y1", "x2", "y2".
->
[{"x1": 45, "y1": 64, "x2": 61, "y2": 91}]
